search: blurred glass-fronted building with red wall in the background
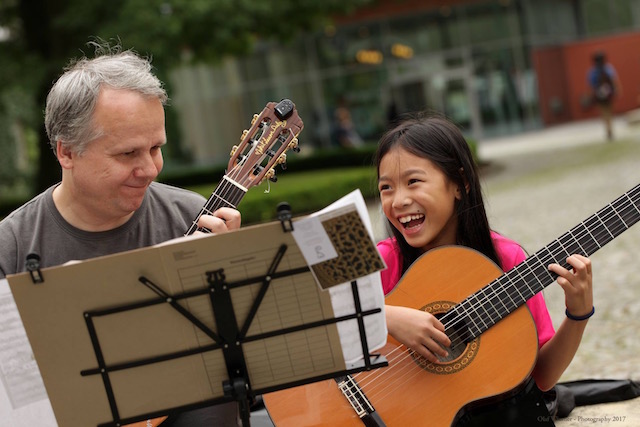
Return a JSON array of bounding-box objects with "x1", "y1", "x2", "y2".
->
[{"x1": 173, "y1": 0, "x2": 640, "y2": 162}]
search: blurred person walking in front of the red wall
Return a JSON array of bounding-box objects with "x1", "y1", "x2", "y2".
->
[{"x1": 587, "y1": 52, "x2": 621, "y2": 141}]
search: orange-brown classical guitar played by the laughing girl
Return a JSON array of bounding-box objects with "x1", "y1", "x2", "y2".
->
[{"x1": 263, "y1": 185, "x2": 640, "y2": 427}]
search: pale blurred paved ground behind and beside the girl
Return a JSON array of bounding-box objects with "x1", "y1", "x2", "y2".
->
[{"x1": 371, "y1": 118, "x2": 640, "y2": 427}]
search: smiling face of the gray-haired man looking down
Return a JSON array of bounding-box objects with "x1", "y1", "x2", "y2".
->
[{"x1": 61, "y1": 88, "x2": 166, "y2": 228}]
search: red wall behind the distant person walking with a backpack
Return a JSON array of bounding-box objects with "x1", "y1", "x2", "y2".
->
[{"x1": 533, "y1": 32, "x2": 640, "y2": 124}]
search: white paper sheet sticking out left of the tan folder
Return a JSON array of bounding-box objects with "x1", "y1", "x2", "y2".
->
[{"x1": 0, "y1": 279, "x2": 58, "y2": 427}]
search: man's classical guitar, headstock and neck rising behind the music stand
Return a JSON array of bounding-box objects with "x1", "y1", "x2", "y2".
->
[{"x1": 126, "y1": 99, "x2": 304, "y2": 427}]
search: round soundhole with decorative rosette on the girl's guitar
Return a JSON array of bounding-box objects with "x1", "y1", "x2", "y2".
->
[{"x1": 411, "y1": 301, "x2": 480, "y2": 375}]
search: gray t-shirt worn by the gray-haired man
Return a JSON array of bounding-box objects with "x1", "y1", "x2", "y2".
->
[{"x1": 0, "y1": 182, "x2": 237, "y2": 427}]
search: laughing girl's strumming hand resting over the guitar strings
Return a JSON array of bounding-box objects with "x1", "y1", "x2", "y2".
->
[{"x1": 385, "y1": 305, "x2": 451, "y2": 362}]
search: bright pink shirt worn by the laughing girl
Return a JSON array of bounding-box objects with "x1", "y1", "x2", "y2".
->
[{"x1": 378, "y1": 232, "x2": 555, "y2": 347}]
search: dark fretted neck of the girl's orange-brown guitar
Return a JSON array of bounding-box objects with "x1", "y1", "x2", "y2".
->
[{"x1": 454, "y1": 185, "x2": 640, "y2": 338}]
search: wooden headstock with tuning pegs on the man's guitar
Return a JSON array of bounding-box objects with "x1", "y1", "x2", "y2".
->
[{"x1": 226, "y1": 99, "x2": 304, "y2": 189}]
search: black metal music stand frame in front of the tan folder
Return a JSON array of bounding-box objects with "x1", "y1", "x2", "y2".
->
[{"x1": 81, "y1": 203, "x2": 388, "y2": 427}]
